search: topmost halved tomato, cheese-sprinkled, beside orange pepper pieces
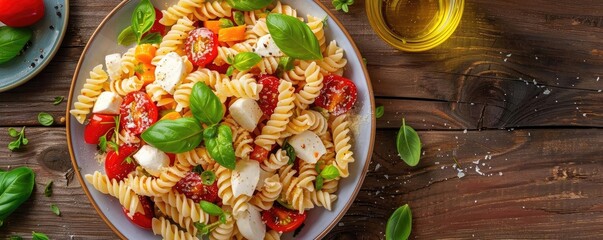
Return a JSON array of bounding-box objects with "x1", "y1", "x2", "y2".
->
[{"x1": 184, "y1": 28, "x2": 218, "y2": 66}]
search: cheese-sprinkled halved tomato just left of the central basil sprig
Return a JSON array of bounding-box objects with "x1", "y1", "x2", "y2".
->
[{"x1": 120, "y1": 91, "x2": 159, "y2": 135}]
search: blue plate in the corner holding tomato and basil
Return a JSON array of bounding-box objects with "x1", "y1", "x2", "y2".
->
[{"x1": 0, "y1": 0, "x2": 69, "y2": 92}]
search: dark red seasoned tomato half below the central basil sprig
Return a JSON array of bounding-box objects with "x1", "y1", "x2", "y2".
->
[{"x1": 174, "y1": 172, "x2": 220, "y2": 203}]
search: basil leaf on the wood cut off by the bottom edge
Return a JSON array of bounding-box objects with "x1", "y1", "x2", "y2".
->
[{"x1": 385, "y1": 204, "x2": 412, "y2": 240}]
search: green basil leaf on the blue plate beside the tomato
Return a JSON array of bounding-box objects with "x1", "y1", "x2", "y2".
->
[{"x1": 0, "y1": 27, "x2": 33, "y2": 64}]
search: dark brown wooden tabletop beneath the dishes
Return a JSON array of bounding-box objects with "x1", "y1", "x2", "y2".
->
[{"x1": 0, "y1": 0, "x2": 603, "y2": 239}]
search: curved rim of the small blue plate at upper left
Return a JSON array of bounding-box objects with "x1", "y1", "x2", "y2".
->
[{"x1": 0, "y1": 0, "x2": 70, "y2": 92}]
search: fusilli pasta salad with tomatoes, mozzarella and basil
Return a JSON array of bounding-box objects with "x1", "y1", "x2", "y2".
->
[{"x1": 70, "y1": 0, "x2": 357, "y2": 239}]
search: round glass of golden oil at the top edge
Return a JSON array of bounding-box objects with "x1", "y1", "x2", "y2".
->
[{"x1": 366, "y1": 0, "x2": 465, "y2": 52}]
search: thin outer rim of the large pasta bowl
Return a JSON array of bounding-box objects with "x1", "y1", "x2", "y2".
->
[{"x1": 65, "y1": 0, "x2": 376, "y2": 239}]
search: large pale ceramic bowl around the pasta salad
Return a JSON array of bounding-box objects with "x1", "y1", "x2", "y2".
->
[{"x1": 67, "y1": 0, "x2": 375, "y2": 239}]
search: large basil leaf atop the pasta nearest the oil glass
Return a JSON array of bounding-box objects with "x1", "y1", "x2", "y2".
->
[{"x1": 266, "y1": 13, "x2": 322, "y2": 60}]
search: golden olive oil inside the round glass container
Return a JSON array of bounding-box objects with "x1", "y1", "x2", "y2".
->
[{"x1": 382, "y1": 0, "x2": 449, "y2": 39}]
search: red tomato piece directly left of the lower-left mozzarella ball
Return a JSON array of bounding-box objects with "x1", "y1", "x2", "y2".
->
[{"x1": 105, "y1": 145, "x2": 138, "y2": 181}]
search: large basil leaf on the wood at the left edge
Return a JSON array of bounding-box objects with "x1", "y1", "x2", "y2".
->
[{"x1": 0, "y1": 167, "x2": 35, "y2": 226}]
